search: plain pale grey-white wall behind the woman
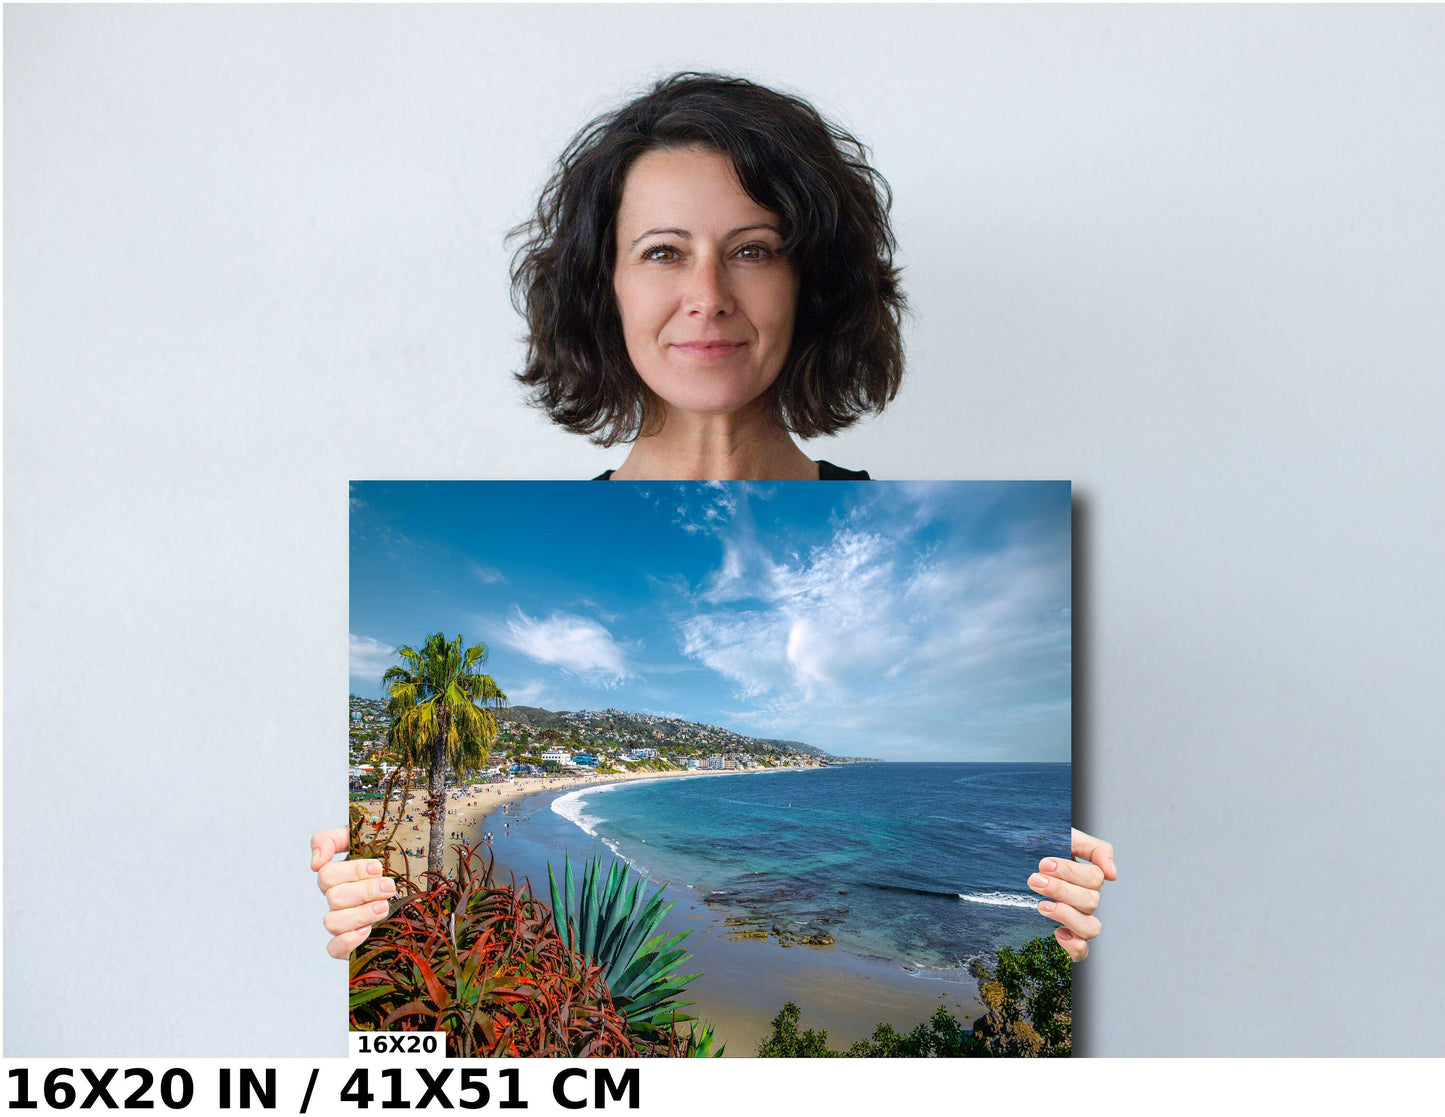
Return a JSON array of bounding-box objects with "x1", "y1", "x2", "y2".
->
[{"x1": 4, "y1": 6, "x2": 1445, "y2": 1056}]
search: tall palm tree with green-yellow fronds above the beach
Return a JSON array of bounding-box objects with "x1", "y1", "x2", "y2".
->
[{"x1": 381, "y1": 633, "x2": 507, "y2": 873}]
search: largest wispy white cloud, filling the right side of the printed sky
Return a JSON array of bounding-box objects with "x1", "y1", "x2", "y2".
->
[{"x1": 679, "y1": 491, "x2": 1069, "y2": 759}]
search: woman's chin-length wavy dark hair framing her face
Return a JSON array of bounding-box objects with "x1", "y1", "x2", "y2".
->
[{"x1": 512, "y1": 72, "x2": 906, "y2": 447}]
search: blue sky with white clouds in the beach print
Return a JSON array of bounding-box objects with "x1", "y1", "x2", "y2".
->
[{"x1": 351, "y1": 481, "x2": 1071, "y2": 760}]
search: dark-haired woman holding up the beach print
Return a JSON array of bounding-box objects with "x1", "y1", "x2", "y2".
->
[{"x1": 311, "y1": 74, "x2": 1116, "y2": 961}]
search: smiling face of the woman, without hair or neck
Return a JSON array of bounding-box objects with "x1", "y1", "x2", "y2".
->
[{"x1": 613, "y1": 147, "x2": 798, "y2": 415}]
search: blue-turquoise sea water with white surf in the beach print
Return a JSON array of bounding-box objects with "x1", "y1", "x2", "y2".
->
[{"x1": 552, "y1": 764, "x2": 1071, "y2": 970}]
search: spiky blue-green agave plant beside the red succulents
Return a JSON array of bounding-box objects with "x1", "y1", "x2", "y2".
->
[{"x1": 546, "y1": 858, "x2": 711, "y2": 1046}]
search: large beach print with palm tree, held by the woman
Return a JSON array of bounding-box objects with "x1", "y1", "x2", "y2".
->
[{"x1": 348, "y1": 481, "x2": 1072, "y2": 1058}]
